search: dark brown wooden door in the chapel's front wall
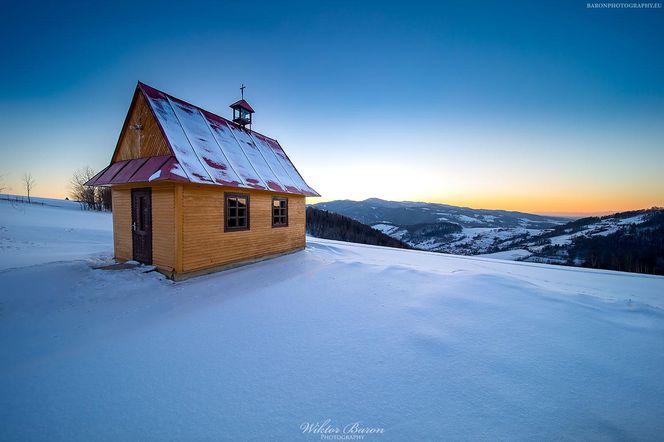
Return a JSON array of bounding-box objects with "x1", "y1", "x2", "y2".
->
[{"x1": 131, "y1": 187, "x2": 152, "y2": 264}]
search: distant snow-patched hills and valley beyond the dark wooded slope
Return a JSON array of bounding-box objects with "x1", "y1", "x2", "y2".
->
[{"x1": 316, "y1": 198, "x2": 664, "y2": 275}]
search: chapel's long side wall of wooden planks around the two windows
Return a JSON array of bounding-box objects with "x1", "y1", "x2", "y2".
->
[{"x1": 182, "y1": 184, "x2": 306, "y2": 273}]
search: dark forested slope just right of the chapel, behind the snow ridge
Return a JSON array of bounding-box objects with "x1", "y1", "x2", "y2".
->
[{"x1": 307, "y1": 207, "x2": 411, "y2": 249}]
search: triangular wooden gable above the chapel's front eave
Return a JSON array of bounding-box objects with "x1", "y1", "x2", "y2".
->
[{"x1": 111, "y1": 92, "x2": 171, "y2": 162}]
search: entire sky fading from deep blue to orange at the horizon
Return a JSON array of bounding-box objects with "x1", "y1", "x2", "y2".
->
[{"x1": 0, "y1": 0, "x2": 664, "y2": 214}]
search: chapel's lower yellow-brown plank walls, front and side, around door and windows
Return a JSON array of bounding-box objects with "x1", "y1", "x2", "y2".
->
[{"x1": 112, "y1": 183, "x2": 306, "y2": 276}]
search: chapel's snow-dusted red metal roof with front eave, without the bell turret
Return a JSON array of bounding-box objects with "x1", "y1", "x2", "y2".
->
[{"x1": 87, "y1": 82, "x2": 320, "y2": 196}]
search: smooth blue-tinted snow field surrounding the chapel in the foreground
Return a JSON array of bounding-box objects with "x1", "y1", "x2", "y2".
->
[{"x1": 0, "y1": 201, "x2": 664, "y2": 441}]
